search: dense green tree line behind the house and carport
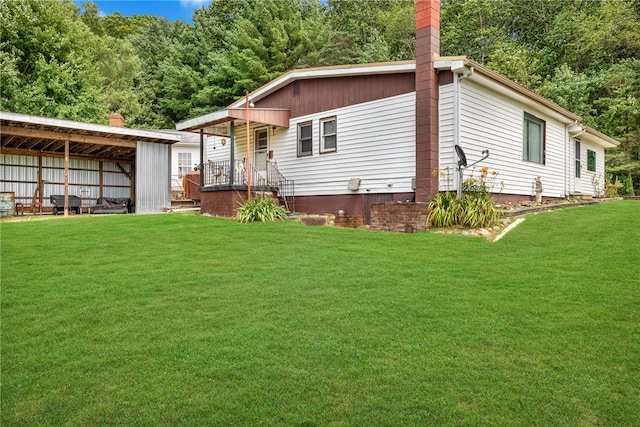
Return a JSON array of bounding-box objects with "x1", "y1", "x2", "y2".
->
[{"x1": 0, "y1": 0, "x2": 640, "y2": 193}]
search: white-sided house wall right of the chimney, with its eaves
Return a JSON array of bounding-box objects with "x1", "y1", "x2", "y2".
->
[{"x1": 436, "y1": 57, "x2": 617, "y2": 198}]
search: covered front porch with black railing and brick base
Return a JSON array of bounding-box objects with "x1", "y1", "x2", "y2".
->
[{"x1": 176, "y1": 103, "x2": 295, "y2": 216}]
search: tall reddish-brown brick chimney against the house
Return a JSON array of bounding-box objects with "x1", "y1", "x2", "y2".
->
[{"x1": 416, "y1": 0, "x2": 440, "y2": 202}]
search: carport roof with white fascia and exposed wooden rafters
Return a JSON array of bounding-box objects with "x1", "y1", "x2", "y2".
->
[{"x1": 0, "y1": 111, "x2": 180, "y2": 162}]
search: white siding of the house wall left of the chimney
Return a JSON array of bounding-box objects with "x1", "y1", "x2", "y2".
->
[{"x1": 202, "y1": 93, "x2": 415, "y2": 196}]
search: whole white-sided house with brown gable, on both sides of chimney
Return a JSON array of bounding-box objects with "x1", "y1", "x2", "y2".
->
[{"x1": 176, "y1": 57, "x2": 617, "y2": 215}]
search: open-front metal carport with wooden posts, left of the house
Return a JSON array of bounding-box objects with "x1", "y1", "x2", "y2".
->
[{"x1": 0, "y1": 111, "x2": 180, "y2": 215}]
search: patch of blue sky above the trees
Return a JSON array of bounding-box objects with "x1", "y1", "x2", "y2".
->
[{"x1": 74, "y1": 0, "x2": 212, "y2": 23}]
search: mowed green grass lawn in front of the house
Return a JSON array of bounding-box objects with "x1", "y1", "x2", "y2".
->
[{"x1": 0, "y1": 201, "x2": 640, "y2": 426}]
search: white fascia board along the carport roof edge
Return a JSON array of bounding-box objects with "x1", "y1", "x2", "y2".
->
[{"x1": 0, "y1": 111, "x2": 180, "y2": 143}]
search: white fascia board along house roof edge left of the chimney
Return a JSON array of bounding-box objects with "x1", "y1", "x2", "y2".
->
[{"x1": 228, "y1": 61, "x2": 416, "y2": 109}]
